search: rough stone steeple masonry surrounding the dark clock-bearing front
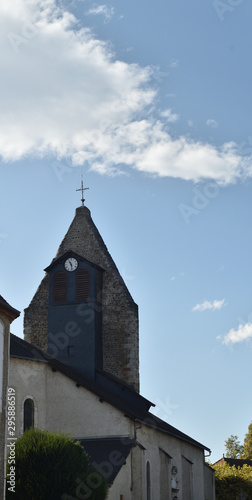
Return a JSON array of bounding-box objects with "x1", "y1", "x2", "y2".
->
[{"x1": 24, "y1": 206, "x2": 139, "y2": 391}]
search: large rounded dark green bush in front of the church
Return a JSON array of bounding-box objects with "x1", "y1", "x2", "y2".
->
[{"x1": 6, "y1": 429, "x2": 107, "y2": 500}]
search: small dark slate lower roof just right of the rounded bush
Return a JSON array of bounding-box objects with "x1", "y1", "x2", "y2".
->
[{"x1": 78, "y1": 438, "x2": 135, "y2": 485}]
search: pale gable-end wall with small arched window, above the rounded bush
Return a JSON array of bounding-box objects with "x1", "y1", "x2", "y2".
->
[{"x1": 10, "y1": 358, "x2": 131, "y2": 438}]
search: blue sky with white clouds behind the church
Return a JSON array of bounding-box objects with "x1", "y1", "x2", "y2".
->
[{"x1": 0, "y1": 0, "x2": 252, "y2": 461}]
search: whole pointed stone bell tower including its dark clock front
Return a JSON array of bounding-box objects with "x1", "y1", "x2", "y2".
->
[{"x1": 24, "y1": 200, "x2": 139, "y2": 392}]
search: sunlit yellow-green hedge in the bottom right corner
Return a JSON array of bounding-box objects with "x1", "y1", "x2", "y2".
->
[{"x1": 212, "y1": 463, "x2": 252, "y2": 500}]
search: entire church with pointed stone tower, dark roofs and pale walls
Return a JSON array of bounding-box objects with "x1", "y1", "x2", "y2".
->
[{"x1": 7, "y1": 203, "x2": 215, "y2": 500}]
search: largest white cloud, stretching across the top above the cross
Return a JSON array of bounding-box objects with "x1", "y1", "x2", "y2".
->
[{"x1": 0, "y1": 0, "x2": 252, "y2": 184}]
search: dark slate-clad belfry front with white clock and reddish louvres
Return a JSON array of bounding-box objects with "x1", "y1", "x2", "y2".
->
[{"x1": 47, "y1": 252, "x2": 103, "y2": 379}]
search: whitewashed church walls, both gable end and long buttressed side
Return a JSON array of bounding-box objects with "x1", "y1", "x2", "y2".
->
[{"x1": 10, "y1": 358, "x2": 214, "y2": 500}]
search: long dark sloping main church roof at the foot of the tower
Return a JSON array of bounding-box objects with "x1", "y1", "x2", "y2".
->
[{"x1": 10, "y1": 334, "x2": 210, "y2": 452}]
